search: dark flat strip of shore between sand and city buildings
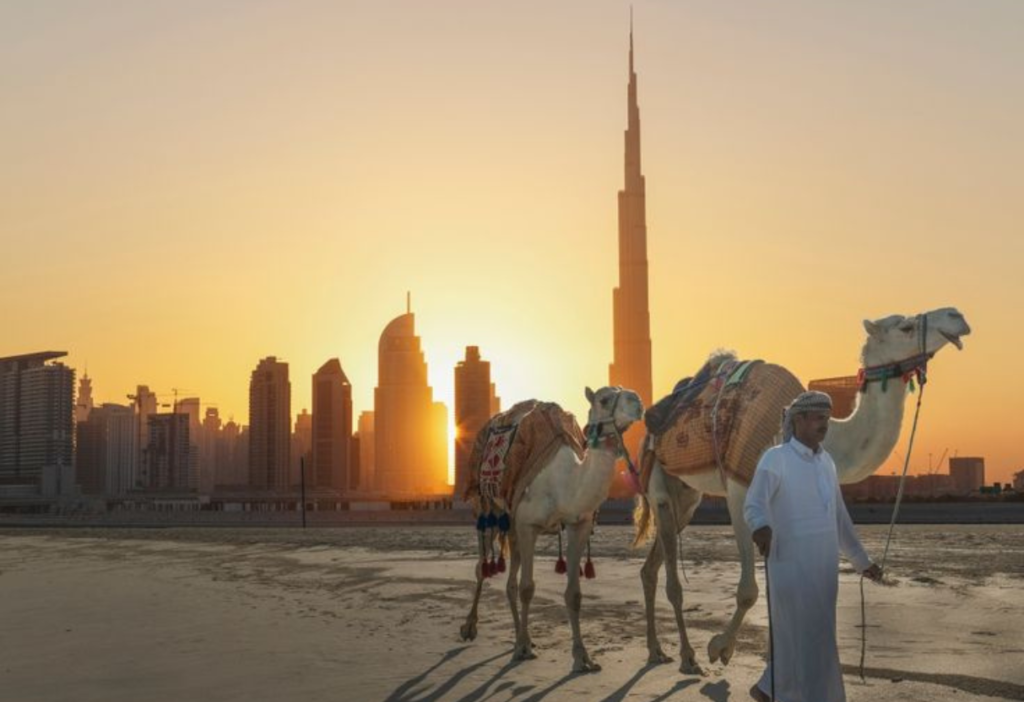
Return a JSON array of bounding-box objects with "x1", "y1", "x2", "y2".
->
[{"x1": 0, "y1": 501, "x2": 1024, "y2": 528}]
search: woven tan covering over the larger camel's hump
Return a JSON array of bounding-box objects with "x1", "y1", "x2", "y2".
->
[{"x1": 654, "y1": 362, "x2": 804, "y2": 485}]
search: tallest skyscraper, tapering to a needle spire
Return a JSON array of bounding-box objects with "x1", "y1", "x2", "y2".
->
[{"x1": 608, "y1": 16, "x2": 652, "y2": 472}]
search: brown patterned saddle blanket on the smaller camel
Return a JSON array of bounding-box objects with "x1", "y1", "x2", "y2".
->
[{"x1": 463, "y1": 400, "x2": 586, "y2": 514}]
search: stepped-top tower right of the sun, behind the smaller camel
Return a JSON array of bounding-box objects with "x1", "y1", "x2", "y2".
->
[{"x1": 455, "y1": 346, "x2": 501, "y2": 496}]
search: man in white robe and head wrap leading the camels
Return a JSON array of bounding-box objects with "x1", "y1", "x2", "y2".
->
[{"x1": 743, "y1": 392, "x2": 882, "y2": 702}]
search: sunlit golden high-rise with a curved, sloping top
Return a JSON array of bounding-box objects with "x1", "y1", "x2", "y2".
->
[{"x1": 372, "y1": 302, "x2": 451, "y2": 495}]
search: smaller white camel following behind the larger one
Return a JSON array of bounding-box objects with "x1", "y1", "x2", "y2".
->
[{"x1": 461, "y1": 387, "x2": 643, "y2": 672}]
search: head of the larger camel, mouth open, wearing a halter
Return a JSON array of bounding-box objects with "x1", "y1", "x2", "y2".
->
[{"x1": 862, "y1": 307, "x2": 971, "y2": 366}]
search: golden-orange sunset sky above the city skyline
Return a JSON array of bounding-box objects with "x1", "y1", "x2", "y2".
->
[{"x1": 0, "y1": 0, "x2": 1024, "y2": 481}]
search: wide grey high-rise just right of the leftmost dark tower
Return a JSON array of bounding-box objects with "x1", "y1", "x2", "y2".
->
[{"x1": 75, "y1": 402, "x2": 138, "y2": 497}]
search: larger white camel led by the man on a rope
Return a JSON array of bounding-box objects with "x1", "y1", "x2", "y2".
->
[{"x1": 635, "y1": 307, "x2": 971, "y2": 674}]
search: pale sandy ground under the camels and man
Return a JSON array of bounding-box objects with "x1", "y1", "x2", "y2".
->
[{"x1": 0, "y1": 525, "x2": 1024, "y2": 702}]
